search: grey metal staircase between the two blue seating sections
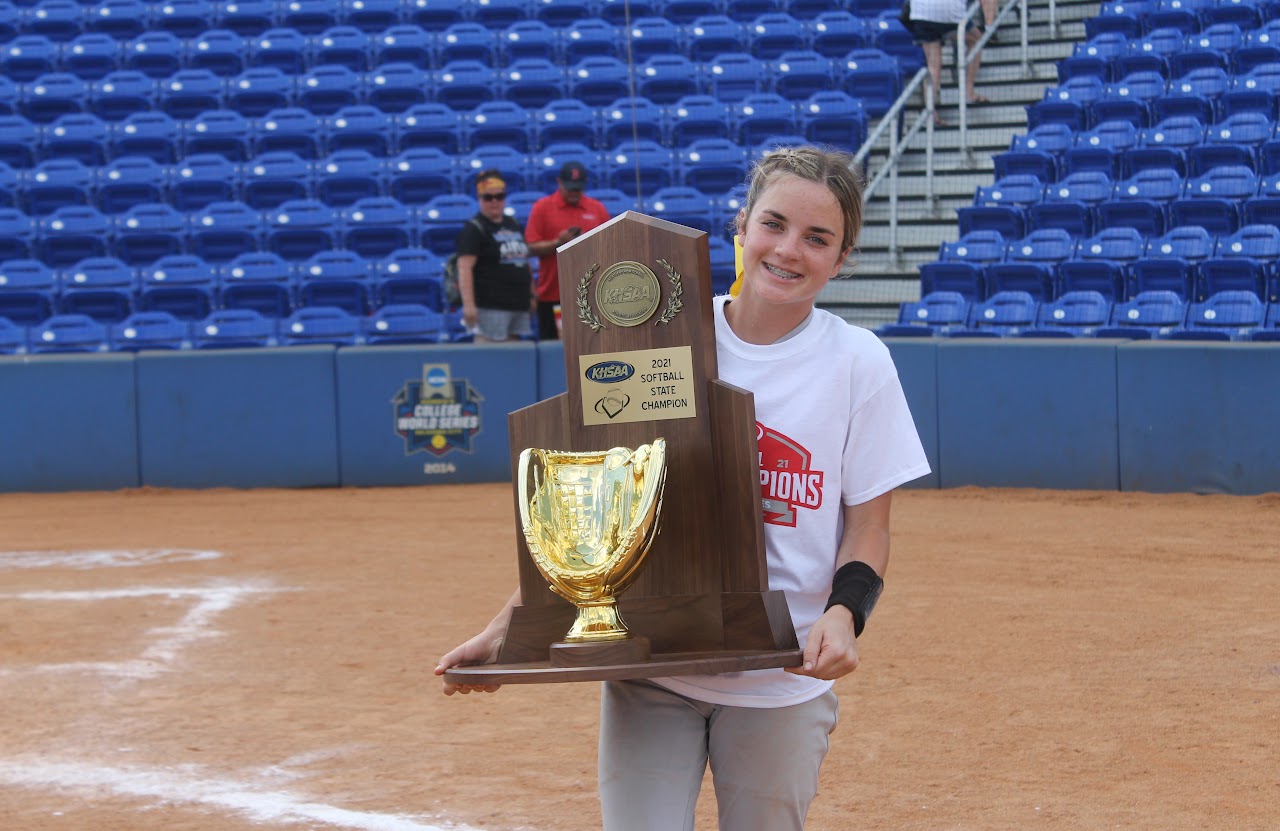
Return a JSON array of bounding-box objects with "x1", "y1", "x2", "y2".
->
[{"x1": 818, "y1": 0, "x2": 1098, "y2": 328}]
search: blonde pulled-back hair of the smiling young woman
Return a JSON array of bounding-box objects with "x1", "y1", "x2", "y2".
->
[{"x1": 737, "y1": 145, "x2": 863, "y2": 251}]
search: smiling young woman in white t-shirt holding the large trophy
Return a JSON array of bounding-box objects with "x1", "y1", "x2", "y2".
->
[{"x1": 436, "y1": 147, "x2": 928, "y2": 831}]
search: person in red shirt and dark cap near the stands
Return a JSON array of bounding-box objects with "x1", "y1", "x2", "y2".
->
[{"x1": 525, "y1": 161, "x2": 611, "y2": 341}]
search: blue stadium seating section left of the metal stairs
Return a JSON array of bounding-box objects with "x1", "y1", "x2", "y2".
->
[{"x1": 0, "y1": 0, "x2": 920, "y2": 352}]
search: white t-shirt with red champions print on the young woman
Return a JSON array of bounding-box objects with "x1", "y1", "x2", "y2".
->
[{"x1": 655, "y1": 296, "x2": 929, "y2": 707}]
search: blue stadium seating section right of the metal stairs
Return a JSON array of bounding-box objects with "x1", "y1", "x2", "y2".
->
[{"x1": 896, "y1": 0, "x2": 1280, "y2": 341}]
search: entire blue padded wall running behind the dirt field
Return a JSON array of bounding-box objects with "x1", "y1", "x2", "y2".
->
[{"x1": 0, "y1": 338, "x2": 1280, "y2": 494}]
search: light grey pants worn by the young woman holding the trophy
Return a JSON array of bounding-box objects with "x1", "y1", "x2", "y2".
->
[{"x1": 600, "y1": 681, "x2": 838, "y2": 831}]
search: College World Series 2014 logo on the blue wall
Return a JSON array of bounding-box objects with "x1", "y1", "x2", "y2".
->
[{"x1": 393, "y1": 364, "x2": 484, "y2": 472}]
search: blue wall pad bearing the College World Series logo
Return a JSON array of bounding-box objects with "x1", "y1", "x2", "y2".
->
[{"x1": 337, "y1": 342, "x2": 539, "y2": 485}]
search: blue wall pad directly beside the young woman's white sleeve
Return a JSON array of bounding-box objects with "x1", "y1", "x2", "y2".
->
[{"x1": 937, "y1": 339, "x2": 1120, "y2": 490}]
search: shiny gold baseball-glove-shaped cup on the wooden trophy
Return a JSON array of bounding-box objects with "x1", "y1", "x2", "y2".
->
[{"x1": 518, "y1": 438, "x2": 667, "y2": 665}]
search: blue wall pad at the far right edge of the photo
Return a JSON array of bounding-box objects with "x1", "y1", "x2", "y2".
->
[{"x1": 1116, "y1": 342, "x2": 1280, "y2": 494}]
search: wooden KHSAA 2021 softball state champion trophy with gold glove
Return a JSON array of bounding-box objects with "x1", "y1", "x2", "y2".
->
[{"x1": 444, "y1": 211, "x2": 803, "y2": 684}]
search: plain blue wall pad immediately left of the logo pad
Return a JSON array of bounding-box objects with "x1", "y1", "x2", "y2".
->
[{"x1": 137, "y1": 346, "x2": 339, "y2": 488}]
